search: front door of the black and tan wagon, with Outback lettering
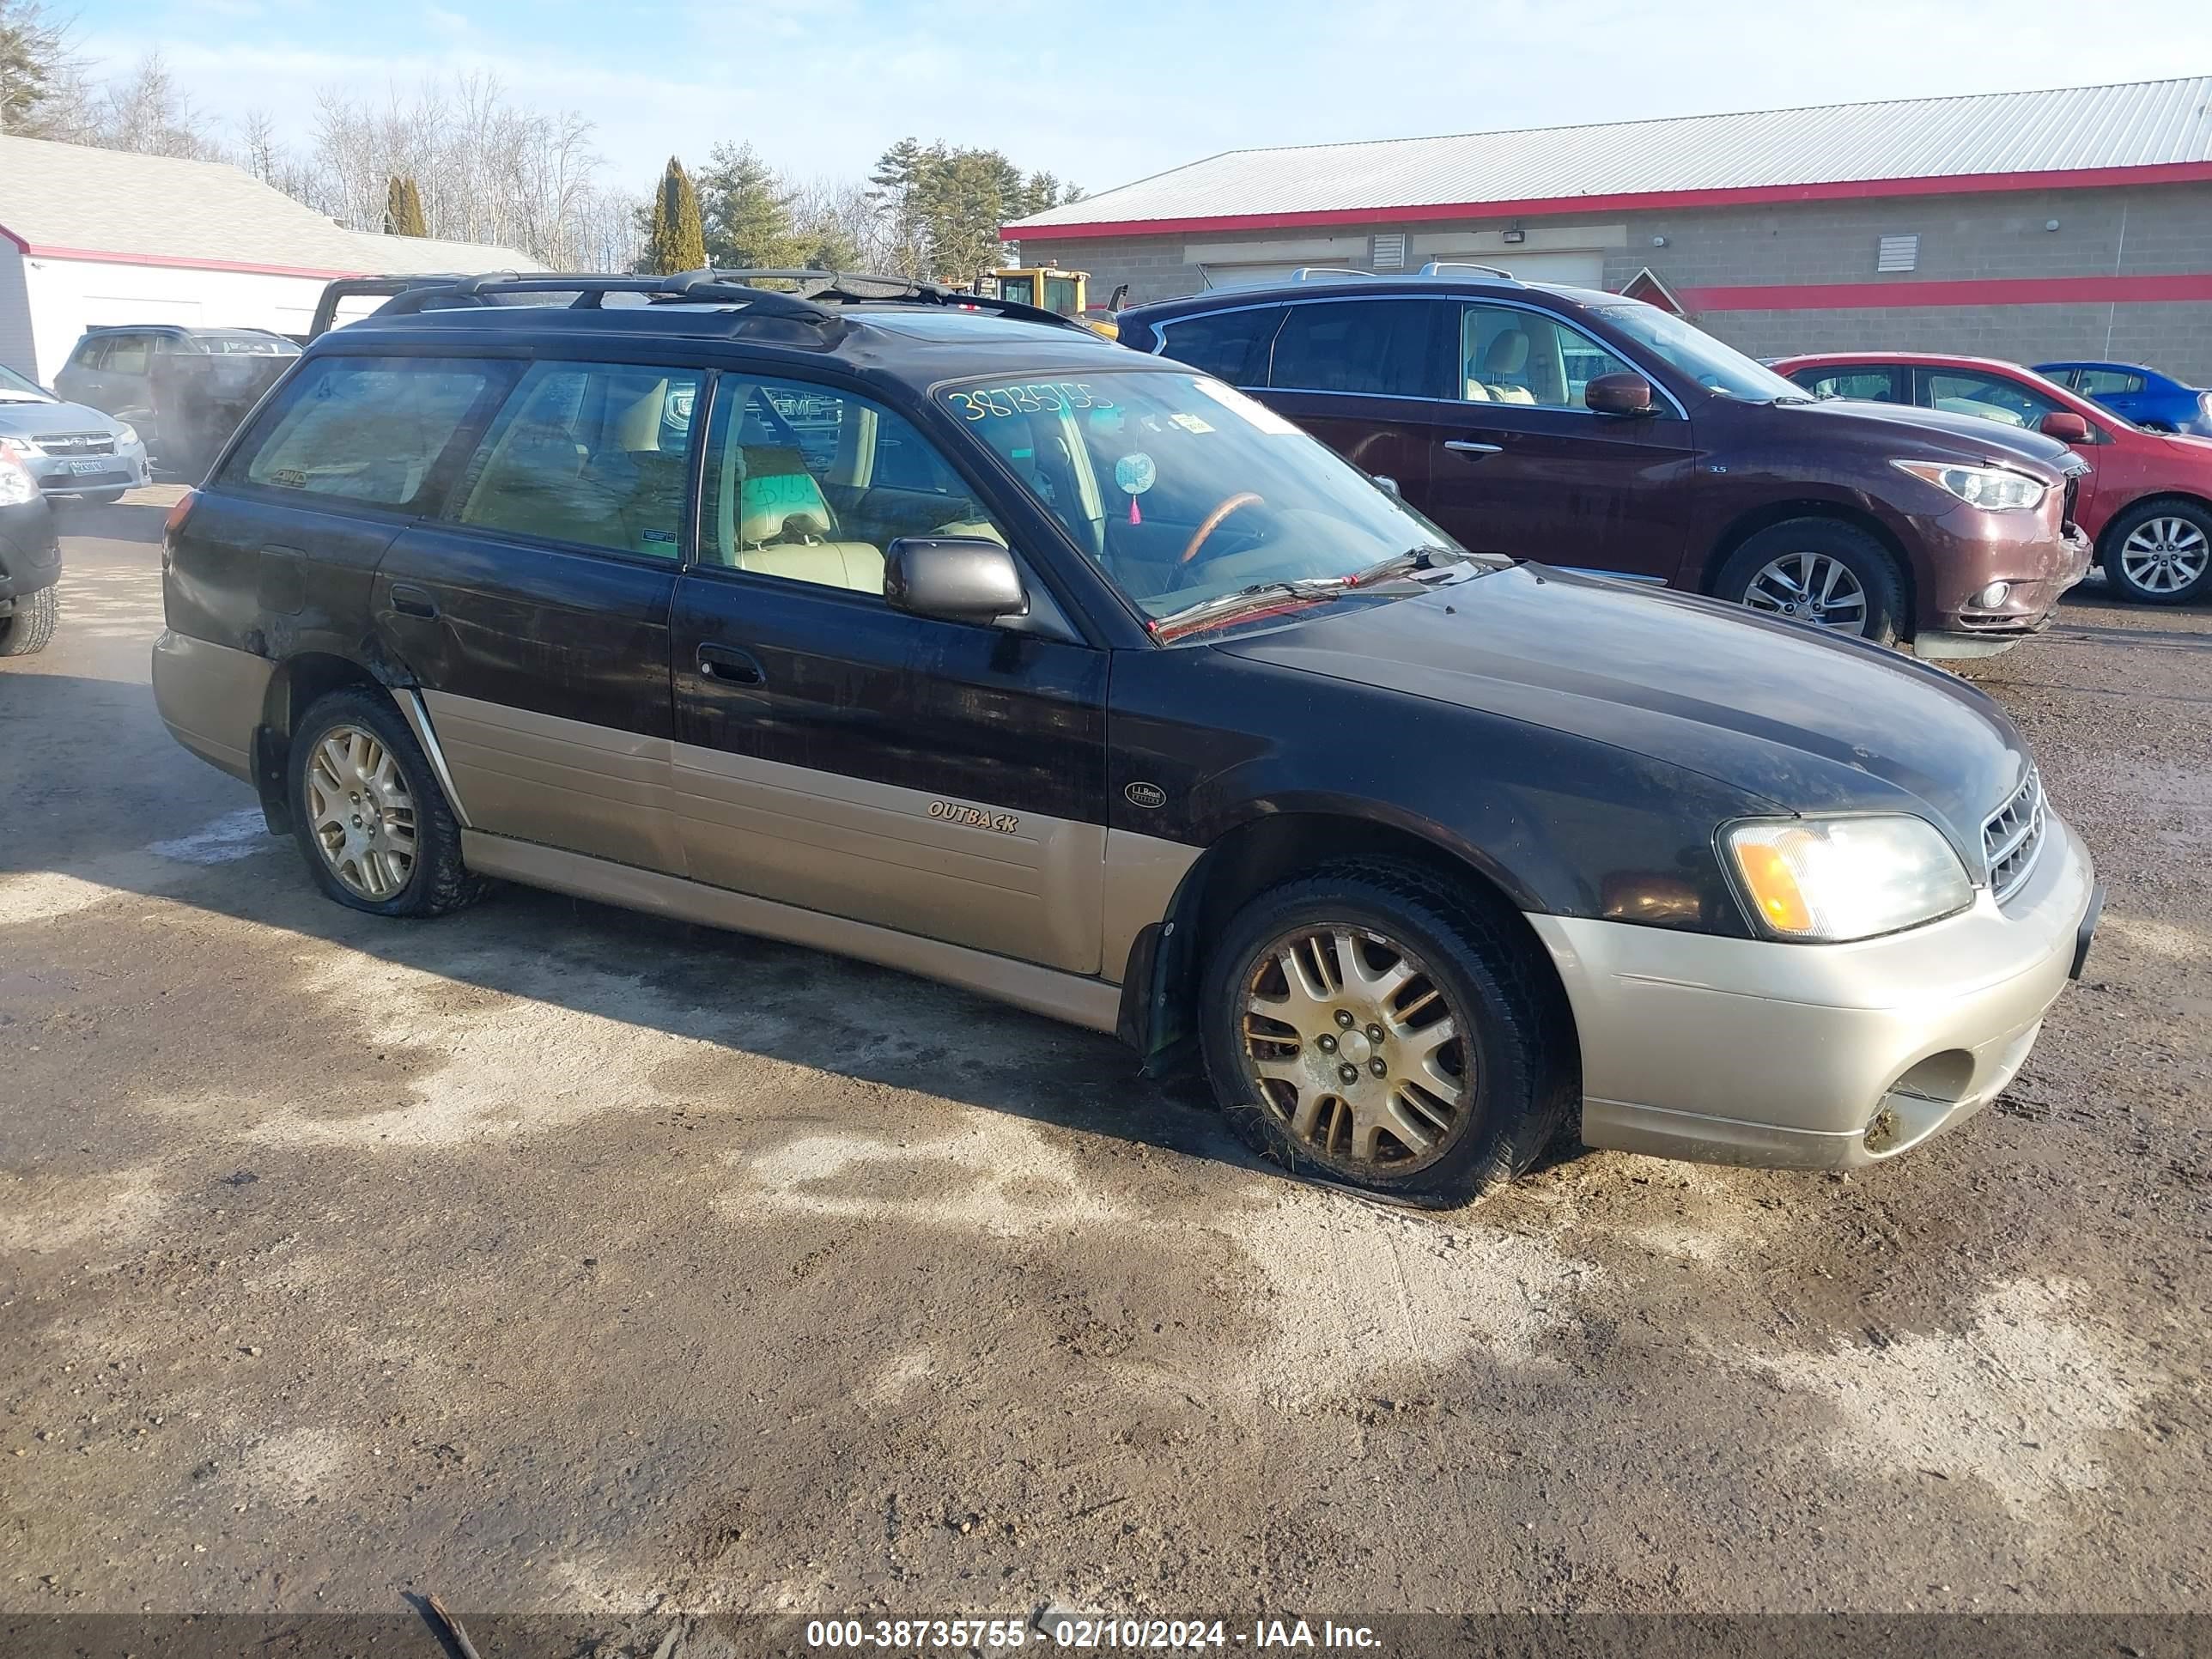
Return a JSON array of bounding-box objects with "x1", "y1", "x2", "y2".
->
[{"x1": 672, "y1": 372, "x2": 1106, "y2": 973}]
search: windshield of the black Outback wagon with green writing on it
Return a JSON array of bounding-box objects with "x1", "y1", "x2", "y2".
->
[{"x1": 940, "y1": 369, "x2": 1464, "y2": 617}]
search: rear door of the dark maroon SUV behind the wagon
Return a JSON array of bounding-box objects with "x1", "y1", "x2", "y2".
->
[{"x1": 1265, "y1": 295, "x2": 1453, "y2": 500}]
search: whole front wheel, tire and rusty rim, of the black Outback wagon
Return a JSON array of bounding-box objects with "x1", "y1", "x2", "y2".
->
[{"x1": 1201, "y1": 860, "x2": 1575, "y2": 1207}]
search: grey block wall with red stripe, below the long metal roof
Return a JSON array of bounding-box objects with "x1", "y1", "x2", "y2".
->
[{"x1": 1030, "y1": 184, "x2": 2212, "y2": 385}]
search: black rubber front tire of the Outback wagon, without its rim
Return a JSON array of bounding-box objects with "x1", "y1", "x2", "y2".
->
[{"x1": 1199, "y1": 858, "x2": 1579, "y2": 1210}]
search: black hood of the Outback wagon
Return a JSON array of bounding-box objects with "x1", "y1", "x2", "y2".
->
[{"x1": 1217, "y1": 564, "x2": 2028, "y2": 869}]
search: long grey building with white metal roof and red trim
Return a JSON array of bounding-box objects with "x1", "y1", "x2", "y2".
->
[{"x1": 1002, "y1": 76, "x2": 2212, "y2": 376}]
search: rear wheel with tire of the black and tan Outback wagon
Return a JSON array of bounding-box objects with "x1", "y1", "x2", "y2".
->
[{"x1": 288, "y1": 686, "x2": 484, "y2": 915}]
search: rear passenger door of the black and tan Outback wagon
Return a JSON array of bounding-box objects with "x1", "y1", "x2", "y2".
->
[{"x1": 374, "y1": 358, "x2": 706, "y2": 872}]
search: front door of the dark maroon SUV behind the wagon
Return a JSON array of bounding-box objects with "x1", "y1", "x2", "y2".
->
[{"x1": 1416, "y1": 301, "x2": 1692, "y2": 581}]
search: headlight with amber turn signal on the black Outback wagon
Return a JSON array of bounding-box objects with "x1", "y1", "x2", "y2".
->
[{"x1": 1721, "y1": 817, "x2": 1973, "y2": 942}]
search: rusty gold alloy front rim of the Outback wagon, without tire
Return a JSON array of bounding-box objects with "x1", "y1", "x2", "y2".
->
[{"x1": 1241, "y1": 927, "x2": 1475, "y2": 1176}]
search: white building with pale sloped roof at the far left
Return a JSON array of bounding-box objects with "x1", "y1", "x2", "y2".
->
[{"x1": 0, "y1": 137, "x2": 540, "y2": 380}]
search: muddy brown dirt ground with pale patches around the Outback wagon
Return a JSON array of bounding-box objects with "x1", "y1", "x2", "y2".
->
[{"x1": 0, "y1": 491, "x2": 2212, "y2": 1620}]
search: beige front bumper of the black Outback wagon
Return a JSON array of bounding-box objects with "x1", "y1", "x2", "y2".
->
[{"x1": 1528, "y1": 814, "x2": 2097, "y2": 1170}]
